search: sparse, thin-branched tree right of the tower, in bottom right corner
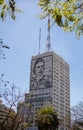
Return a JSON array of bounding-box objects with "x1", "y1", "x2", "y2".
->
[{"x1": 71, "y1": 101, "x2": 83, "y2": 130}]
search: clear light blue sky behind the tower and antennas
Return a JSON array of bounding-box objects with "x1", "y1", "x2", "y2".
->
[{"x1": 0, "y1": 0, "x2": 83, "y2": 106}]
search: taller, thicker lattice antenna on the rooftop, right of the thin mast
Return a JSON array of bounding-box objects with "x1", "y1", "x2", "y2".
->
[{"x1": 46, "y1": 15, "x2": 51, "y2": 51}]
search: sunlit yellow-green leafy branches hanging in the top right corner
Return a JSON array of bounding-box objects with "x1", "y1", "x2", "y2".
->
[{"x1": 38, "y1": 0, "x2": 83, "y2": 38}]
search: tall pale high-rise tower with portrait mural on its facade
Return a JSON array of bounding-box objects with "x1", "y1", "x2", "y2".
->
[{"x1": 17, "y1": 52, "x2": 70, "y2": 130}]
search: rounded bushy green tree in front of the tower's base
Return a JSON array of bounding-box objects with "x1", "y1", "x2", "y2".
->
[{"x1": 36, "y1": 107, "x2": 59, "y2": 130}]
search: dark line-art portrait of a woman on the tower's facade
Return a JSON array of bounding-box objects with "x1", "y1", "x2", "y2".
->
[{"x1": 31, "y1": 58, "x2": 52, "y2": 89}]
